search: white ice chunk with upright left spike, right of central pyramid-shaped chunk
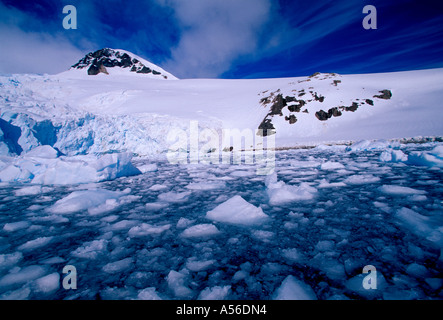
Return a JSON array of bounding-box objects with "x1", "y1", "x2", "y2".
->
[{"x1": 265, "y1": 173, "x2": 317, "y2": 205}]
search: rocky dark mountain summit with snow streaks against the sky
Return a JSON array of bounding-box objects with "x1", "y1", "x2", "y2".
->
[{"x1": 71, "y1": 48, "x2": 177, "y2": 79}]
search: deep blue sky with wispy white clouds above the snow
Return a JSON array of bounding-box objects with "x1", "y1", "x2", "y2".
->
[{"x1": 0, "y1": 0, "x2": 443, "y2": 78}]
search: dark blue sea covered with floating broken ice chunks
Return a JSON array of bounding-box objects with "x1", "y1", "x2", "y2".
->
[{"x1": 0, "y1": 144, "x2": 443, "y2": 299}]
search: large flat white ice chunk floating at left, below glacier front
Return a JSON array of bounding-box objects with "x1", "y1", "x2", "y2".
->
[{"x1": 47, "y1": 189, "x2": 124, "y2": 213}]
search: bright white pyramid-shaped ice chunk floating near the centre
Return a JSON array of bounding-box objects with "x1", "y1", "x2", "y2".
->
[{"x1": 206, "y1": 195, "x2": 269, "y2": 225}]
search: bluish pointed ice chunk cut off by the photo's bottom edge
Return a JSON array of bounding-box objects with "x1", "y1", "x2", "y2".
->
[{"x1": 273, "y1": 275, "x2": 317, "y2": 300}]
